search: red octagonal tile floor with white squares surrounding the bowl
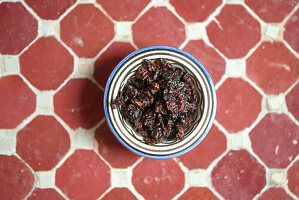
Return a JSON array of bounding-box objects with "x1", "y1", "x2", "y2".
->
[{"x1": 0, "y1": 0, "x2": 299, "y2": 200}]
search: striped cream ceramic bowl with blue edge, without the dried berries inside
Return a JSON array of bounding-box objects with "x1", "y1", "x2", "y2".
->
[{"x1": 104, "y1": 46, "x2": 217, "y2": 159}]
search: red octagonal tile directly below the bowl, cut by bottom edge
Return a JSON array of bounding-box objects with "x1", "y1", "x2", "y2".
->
[{"x1": 132, "y1": 158, "x2": 185, "y2": 200}]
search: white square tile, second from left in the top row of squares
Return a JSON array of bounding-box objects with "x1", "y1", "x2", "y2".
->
[{"x1": 115, "y1": 22, "x2": 132, "y2": 42}]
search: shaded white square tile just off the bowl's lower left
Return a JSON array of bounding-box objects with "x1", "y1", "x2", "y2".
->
[{"x1": 76, "y1": 128, "x2": 94, "y2": 149}]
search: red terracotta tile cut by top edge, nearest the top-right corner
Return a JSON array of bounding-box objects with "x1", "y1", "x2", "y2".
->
[{"x1": 245, "y1": 0, "x2": 299, "y2": 23}]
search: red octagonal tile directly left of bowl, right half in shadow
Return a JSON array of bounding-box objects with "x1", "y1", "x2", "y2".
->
[{"x1": 54, "y1": 78, "x2": 104, "y2": 129}]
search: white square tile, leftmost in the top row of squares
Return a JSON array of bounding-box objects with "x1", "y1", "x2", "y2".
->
[{"x1": 39, "y1": 20, "x2": 60, "y2": 37}]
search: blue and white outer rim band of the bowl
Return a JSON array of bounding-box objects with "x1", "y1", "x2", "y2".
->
[{"x1": 103, "y1": 46, "x2": 217, "y2": 159}]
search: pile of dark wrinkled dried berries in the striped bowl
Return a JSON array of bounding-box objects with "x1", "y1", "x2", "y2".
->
[{"x1": 112, "y1": 59, "x2": 200, "y2": 144}]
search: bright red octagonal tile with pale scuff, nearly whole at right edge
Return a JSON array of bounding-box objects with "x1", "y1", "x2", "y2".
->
[{"x1": 246, "y1": 42, "x2": 299, "y2": 94}]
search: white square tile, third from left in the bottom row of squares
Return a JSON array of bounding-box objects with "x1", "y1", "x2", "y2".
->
[{"x1": 188, "y1": 169, "x2": 211, "y2": 187}]
